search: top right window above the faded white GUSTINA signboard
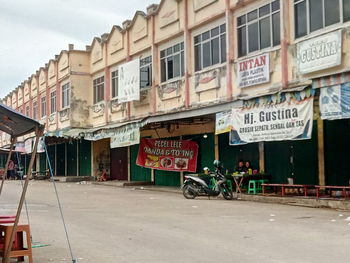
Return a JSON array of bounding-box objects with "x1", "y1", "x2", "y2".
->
[{"x1": 294, "y1": 0, "x2": 344, "y2": 38}]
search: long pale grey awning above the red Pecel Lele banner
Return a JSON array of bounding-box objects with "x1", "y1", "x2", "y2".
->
[{"x1": 141, "y1": 101, "x2": 243, "y2": 127}]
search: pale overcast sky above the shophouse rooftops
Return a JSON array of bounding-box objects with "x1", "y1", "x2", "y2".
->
[{"x1": 0, "y1": 0, "x2": 159, "y2": 98}]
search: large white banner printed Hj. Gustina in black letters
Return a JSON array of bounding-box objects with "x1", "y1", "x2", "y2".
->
[{"x1": 230, "y1": 97, "x2": 313, "y2": 145}]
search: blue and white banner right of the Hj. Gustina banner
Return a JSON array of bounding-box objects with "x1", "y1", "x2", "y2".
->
[{"x1": 320, "y1": 83, "x2": 350, "y2": 120}]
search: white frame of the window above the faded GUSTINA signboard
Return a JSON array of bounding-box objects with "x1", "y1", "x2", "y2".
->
[{"x1": 293, "y1": 0, "x2": 349, "y2": 40}]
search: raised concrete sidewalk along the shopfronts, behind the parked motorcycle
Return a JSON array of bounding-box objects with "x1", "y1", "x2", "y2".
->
[{"x1": 92, "y1": 181, "x2": 350, "y2": 211}]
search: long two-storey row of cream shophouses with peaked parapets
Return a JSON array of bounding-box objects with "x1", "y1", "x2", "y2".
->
[{"x1": 0, "y1": 0, "x2": 350, "y2": 186}]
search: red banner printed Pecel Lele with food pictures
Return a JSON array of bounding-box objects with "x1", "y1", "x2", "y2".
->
[{"x1": 136, "y1": 138, "x2": 198, "y2": 172}]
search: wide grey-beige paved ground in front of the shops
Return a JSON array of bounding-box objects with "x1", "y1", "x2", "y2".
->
[{"x1": 0, "y1": 181, "x2": 350, "y2": 263}]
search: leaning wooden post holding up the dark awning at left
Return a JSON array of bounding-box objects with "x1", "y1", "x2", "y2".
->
[{"x1": 3, "y1": 128, "x2": 43, "y2": 263}]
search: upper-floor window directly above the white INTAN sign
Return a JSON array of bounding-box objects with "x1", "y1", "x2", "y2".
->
[{"x1": 237, "y1": 0, "x2": 281, "y2": 57}]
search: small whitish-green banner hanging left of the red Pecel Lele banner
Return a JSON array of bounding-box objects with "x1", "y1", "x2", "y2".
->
[{"x1": 111, "y1": 124, "x2": 140, "y2": 149}]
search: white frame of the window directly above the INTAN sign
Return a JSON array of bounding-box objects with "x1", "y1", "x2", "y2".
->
[{"x1": 235, "y1": 0, "x2": 280, "y2": 58}]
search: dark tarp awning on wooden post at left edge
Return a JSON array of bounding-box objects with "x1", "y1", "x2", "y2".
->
[{"x1": 0, "y1": 103, "x2": 42, "y2": 137}]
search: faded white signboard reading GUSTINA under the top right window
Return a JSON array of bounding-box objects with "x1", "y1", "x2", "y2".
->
[{"x1": 297, "y1": 30, "x2": 342, "y2": 74}]
